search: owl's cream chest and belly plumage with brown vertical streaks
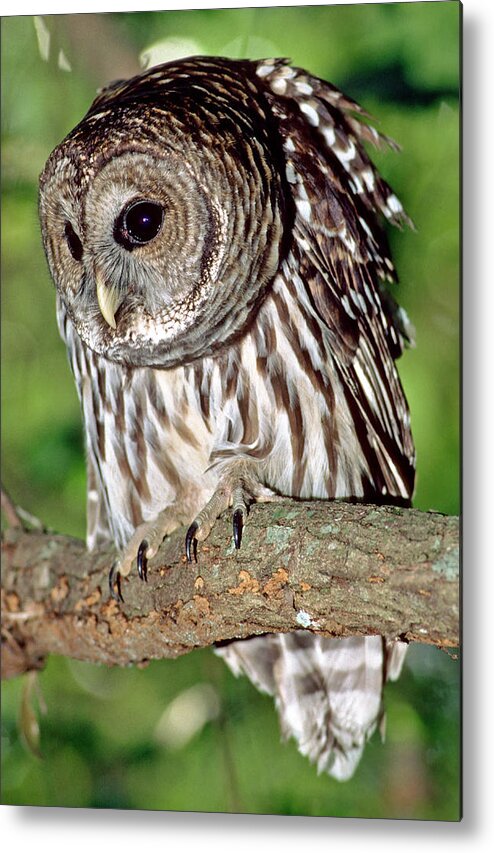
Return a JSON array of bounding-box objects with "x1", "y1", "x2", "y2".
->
[{"x1": 59, "y1": 253, "x2": 408, "y2": 546}]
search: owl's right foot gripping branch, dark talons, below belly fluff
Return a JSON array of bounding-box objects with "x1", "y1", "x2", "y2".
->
[{"x1": 185, "y1": 460, "x2": 282, "y2": 563}]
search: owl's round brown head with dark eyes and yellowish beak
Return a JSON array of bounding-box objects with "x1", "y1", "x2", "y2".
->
[{"x1": 40, "y1": 59, "x2": 282, "y2": 367}]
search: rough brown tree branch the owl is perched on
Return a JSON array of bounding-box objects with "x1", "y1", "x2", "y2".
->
[{"x1": 2, "y1": 501, "x2": 459, "y2": 677}]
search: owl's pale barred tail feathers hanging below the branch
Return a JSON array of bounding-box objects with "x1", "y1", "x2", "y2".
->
[{"x1": 217, "y1": 631, "x2": 406, "y2": 781}]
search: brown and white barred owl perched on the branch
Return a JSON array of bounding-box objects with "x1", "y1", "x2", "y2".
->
[{"x1": 40, "y1": 57, "x2": 414, "y2": 779}]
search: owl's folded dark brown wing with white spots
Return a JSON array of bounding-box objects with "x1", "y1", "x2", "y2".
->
[{"x1": 258, "y1": 62, "x2": 415, "y2": 502}]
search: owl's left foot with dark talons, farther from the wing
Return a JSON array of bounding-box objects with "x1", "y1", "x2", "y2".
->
[{"x1": 108, "y1": 507, "x2": 181, "y2": 601}]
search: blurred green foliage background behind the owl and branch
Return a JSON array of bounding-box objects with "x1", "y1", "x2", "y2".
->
[{"x1": 1, "y1": 2, "x2": 461, "y2": 820}]
